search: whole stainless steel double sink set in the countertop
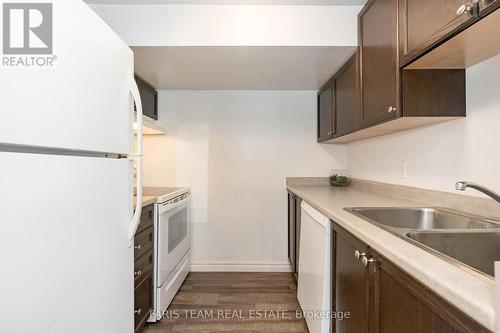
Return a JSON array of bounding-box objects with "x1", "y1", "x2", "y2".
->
[{"x1": 346, "y1": 207, "x2": 500, "y2": 281}]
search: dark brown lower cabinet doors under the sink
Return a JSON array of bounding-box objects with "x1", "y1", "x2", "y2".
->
[{"x1": 332, "y1": 223, "x2": 489, "y2": 333}]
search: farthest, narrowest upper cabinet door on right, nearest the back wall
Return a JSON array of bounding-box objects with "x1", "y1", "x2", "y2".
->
[{"x1": 318, "y1": 81, "x2": 335, "y2": 142}]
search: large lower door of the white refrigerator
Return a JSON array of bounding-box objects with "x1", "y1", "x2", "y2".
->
[{"x1": 0, "y1": 152, "x2": 134, "y2": 333}]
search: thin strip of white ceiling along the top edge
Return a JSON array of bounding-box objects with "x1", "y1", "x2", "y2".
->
[{"x1": 85, "y1": 0, "x2": 366, "y2": 6}]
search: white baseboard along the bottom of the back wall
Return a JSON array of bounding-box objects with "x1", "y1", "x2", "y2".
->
[{"x1": 191, "y1": 262, "x2": 291, "y2": 273}]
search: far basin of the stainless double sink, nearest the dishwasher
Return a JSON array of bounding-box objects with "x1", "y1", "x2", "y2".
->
[{"x1": 348, "y1": 207, "x2": 500, "y2": 230}]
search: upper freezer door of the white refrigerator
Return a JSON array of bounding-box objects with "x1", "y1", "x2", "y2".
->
[{"x1": 0, "y1": 0, "x2": 134, "y2": 154}]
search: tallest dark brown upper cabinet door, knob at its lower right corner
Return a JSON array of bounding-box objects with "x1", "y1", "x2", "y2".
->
[{"x1": 359, "y1": 0, "x2": 400, "y2": 127}]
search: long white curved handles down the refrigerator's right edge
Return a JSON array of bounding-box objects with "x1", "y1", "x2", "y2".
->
[{"x1": 128, "y1": 75, "x2": 142, "y2": 243}]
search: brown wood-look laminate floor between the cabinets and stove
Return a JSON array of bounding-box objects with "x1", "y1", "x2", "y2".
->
[{"x1": 144, "y1": 273, "x2": 308, "y2": 333}]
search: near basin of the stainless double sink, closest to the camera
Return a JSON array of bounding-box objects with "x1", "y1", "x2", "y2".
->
[{"x1": 406, "y1": 231, "x2": 500, "y2": 277}]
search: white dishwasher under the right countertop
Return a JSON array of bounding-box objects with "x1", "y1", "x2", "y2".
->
[{"x1": 297, "y1": 201, "x2": 331, "y2": 333}]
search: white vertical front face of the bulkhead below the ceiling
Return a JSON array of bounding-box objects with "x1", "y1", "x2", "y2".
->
[{"x1": 87, "y1": 5, "x2": 361, "y2": 46}]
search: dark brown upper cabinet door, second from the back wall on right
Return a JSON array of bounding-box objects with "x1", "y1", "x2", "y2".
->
[{"x1": 333, "y1": 53, "x2": 360, "y2": 137}]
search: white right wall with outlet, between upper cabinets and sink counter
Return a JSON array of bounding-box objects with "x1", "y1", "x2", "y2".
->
[{"x1": 348, "y1": 56, "x2": 500, "y2": 195}]
